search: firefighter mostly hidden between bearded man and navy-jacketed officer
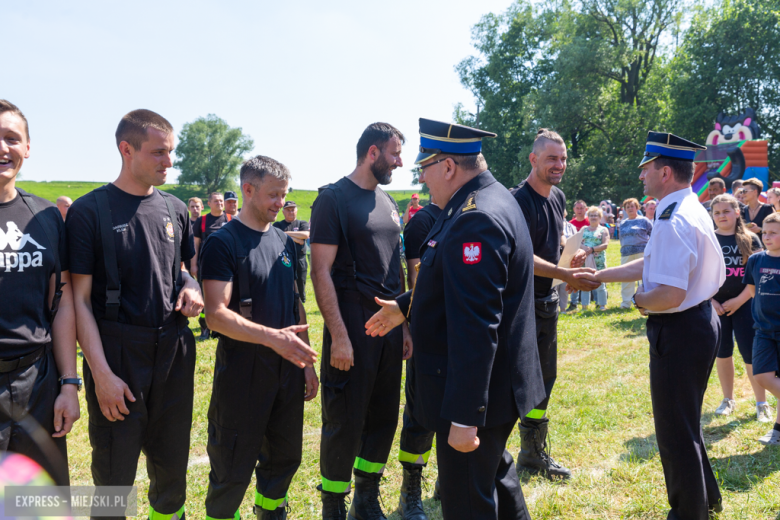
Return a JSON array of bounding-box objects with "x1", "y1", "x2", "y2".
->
[{"x1": 398, "y1": 194, "x2": 441, "y2": 520}]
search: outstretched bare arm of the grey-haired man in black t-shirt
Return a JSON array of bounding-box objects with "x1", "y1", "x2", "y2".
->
[{"x1": 203, "y1": 280, "x2": 317, "y2": 368}]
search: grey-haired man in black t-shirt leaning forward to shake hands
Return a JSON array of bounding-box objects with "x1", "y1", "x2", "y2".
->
[{"x1": 202, "y1": 155, "x2": 318, "y2": 520}]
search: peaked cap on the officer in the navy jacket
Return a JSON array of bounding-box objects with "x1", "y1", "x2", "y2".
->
[{"x1": 414, "y1": 117, "x2": 496, "y2": 164}]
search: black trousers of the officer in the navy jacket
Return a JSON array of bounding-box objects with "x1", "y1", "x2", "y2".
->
[{"x1": 436, "y1": 421, "x2": 531, "y2": 520}]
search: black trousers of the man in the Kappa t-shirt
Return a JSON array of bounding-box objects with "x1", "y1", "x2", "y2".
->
[{"x1": 0, "y1": 346, "x2": 70, "y2": 486}]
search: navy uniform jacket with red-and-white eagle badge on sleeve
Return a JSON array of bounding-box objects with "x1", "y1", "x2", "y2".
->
[{"x1": 397, "y1": 171, "x2": 545, "y2": 431}]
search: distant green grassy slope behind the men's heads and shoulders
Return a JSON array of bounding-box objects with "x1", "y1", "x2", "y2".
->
[{"x1": 16, "y1": 179, "x2": 425, "y2": 220}]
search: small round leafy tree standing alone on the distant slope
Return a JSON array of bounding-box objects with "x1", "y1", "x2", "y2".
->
[{"x1": 174, "y1": 114, "x2": 254, "y2": 193}]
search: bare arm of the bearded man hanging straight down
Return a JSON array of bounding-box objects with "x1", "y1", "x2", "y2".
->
[{"x1": 311, "y1": 244, "x2": 354, "y2": 370}]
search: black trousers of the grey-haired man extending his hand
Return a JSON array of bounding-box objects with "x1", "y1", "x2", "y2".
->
[{"x1": 206, "y1": 336, "x2": 306, "y2": 519}]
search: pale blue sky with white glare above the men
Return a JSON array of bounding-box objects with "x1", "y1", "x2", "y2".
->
[{"x1": 9, "y1": 0, "x2": 511, "y2": 189}]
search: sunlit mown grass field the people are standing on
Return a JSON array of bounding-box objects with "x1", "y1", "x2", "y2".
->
[{"x1": 58, "y1": 237, "x2": 780, "y2": 520}]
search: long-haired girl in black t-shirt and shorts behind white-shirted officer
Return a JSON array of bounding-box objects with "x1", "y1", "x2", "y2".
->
[{"x1": 710, "y1": 195, "x2": 772, "y2": 422}]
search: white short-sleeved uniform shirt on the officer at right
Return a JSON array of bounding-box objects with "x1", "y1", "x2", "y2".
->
[{"x1": 642, "y1": 188, "x2": 726, "y2": 314}]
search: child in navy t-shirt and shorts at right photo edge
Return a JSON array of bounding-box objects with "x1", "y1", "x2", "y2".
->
[{"x1": 743, "y1": 213, "x2": 780, "y2": 446}]
